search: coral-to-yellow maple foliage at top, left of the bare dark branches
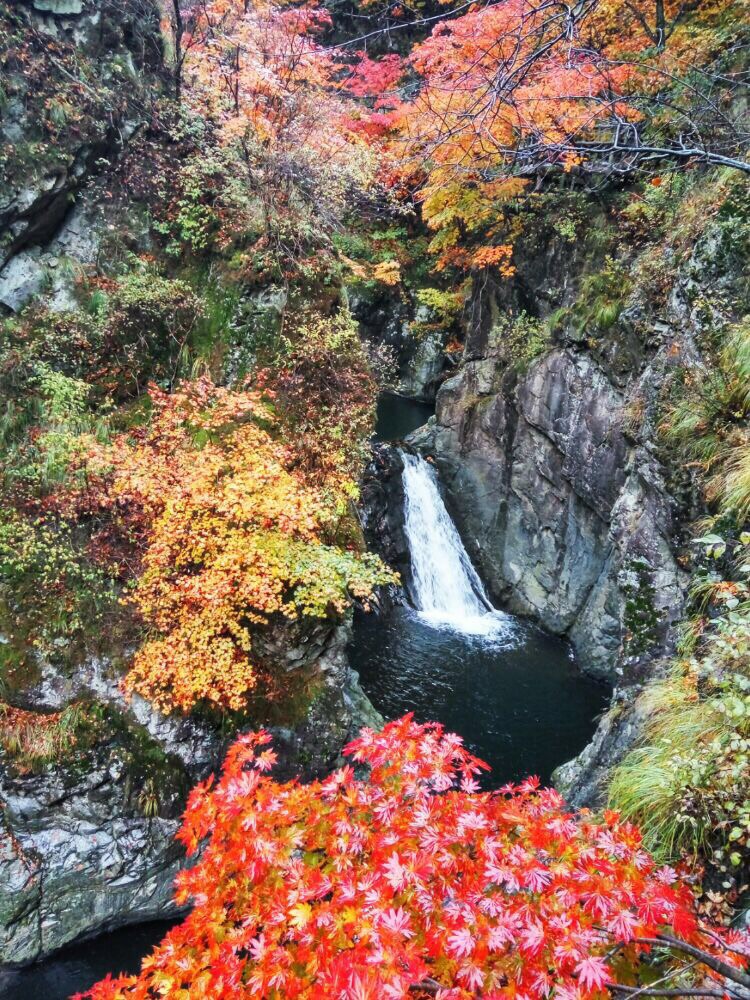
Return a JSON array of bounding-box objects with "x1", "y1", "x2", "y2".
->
[{"x1": 402, "y1": 0, "x2": 634, "y2": 276}]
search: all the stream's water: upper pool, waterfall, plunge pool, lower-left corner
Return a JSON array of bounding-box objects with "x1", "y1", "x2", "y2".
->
[{"x1": 0, "y1": 394, "x2": 608, "y2": 1000}]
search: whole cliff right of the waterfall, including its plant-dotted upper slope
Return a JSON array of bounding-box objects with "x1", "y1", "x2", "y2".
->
[{"x1": 378, "y1": 184, "x2": 743, "y2": 804}]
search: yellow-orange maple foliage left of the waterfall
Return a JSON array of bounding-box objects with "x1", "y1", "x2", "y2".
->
[{"x1": 58, "y1": 378, "x2": 393, "y2": 712}]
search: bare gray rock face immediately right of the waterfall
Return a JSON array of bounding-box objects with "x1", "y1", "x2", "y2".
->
[{"x1": 411, "y1": 349, "x2": 683, "y2": 679}]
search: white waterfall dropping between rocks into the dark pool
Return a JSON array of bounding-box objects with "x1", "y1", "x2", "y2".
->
[{"x1": 402, "y1": 452, "x2": 505, "y2": 633}]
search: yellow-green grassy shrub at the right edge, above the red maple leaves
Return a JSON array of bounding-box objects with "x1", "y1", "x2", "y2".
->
[{"x1": 610, "y1": 543, "x2": 750, "y2": 871}]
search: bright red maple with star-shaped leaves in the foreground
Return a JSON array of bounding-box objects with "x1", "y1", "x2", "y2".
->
[{"x1": 79, "y1": 716, "x2": 747, "y2": 1000}]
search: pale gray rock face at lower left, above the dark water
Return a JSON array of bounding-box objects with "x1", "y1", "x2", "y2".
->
[{"x1": 0, "y1": 758, "x2": 184, "y2": 965}]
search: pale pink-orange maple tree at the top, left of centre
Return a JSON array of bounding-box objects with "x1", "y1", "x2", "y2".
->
[{"x1": 182, "y1": 0, "x2": 388, "y2": 267}]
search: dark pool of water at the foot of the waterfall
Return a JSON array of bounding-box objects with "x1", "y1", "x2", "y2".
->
[{"x1": 350, "y1": 607, "x2": 609, "y2": 788}]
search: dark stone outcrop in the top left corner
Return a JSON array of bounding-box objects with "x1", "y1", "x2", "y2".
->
[{"x1": 0, "y1": 0, "x2": 162, "y2": 313}]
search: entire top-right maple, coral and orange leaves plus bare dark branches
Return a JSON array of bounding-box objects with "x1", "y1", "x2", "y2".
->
[{"x1": 340, "y1": 0, "x2": 750, "y2": 276}]
